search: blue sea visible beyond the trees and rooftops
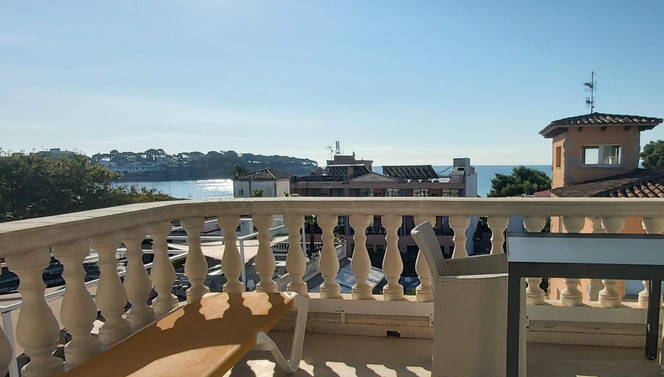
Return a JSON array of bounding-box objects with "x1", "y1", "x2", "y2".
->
[{"x1": 115, "y1": 165, "x2": 551, "y2": 199}]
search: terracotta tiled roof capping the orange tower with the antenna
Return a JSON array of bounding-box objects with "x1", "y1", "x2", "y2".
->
[{"x1": 540, "y1": 113, "x2": 662, "y2": 138}]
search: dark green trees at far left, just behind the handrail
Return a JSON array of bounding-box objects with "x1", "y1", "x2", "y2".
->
[{"x1": 0, "y1": 154, "x2": 172, "y2": 221}]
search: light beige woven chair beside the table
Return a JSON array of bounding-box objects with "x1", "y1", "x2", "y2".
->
[{"x1": 411, "y1": 222, "x2": 525, "y2": 377}]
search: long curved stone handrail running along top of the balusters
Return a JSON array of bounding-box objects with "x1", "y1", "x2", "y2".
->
[{"x1": 0, "y1": 197, "x2": 664, "y2": 253}]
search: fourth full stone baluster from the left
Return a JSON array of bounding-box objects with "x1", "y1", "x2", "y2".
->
[{"x1": 123, "y1": 228, "x2": 154, "y2": 331}]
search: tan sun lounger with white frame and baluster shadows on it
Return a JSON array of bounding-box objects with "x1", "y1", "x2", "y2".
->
[{"x1": 65, "y1": 292, "x2": 309, "y2": 377}]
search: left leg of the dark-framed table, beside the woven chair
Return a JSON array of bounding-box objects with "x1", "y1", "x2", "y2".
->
[{"x1": 506, "y1": 274, "x2": 522, "y2": 377}]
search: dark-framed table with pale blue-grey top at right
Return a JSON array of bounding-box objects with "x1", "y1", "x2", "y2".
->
[{"x1": 506, "y1": 233, "x2": 664, "y2": 377}]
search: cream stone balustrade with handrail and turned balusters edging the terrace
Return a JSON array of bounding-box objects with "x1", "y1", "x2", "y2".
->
[{"x1": 0, "y1": 198, "x2": 664, "y2": 377}]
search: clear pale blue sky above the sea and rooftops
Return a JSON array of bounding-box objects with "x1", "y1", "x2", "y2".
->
[{"x1": 0, "y1": 0, "x2": 664, "y2": 165}]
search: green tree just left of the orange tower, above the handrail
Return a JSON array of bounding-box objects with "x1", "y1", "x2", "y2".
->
[{"x1": 487, "y1": 166, "x2": 551, "y2": 197}]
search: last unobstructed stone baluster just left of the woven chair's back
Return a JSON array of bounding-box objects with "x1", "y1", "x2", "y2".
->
[{"x1": 382, "y1": 215, "x2": 404, "y2": 301}]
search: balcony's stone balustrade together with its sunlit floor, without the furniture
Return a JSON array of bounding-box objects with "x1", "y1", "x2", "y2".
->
[{"x1": 0, "y1": 198, "x2": 664, "y2": 377}]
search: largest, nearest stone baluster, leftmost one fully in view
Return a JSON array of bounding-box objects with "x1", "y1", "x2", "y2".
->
[{"x1": 5, "y1": 249, "x2": 64, "y2": 377}]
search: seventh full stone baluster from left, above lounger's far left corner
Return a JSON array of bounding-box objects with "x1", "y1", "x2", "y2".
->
[{"x1": 217, "y1": 215, "x2": 244, "y2": 293}]
